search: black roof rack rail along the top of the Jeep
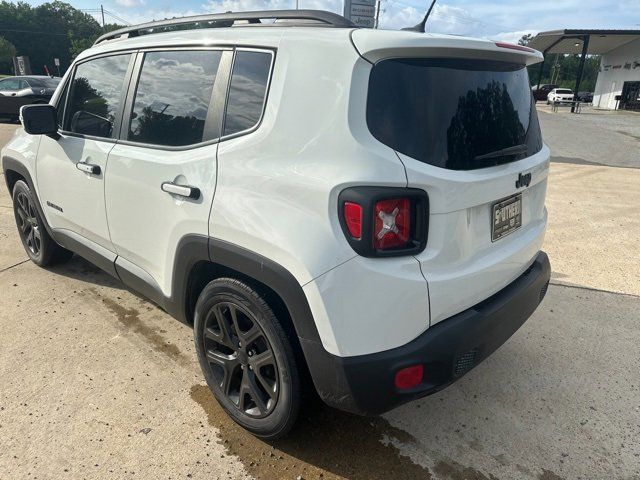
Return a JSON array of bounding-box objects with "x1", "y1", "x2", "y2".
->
[{"x1": 93, "y1": 10, "x2": 356, "y2": 46}]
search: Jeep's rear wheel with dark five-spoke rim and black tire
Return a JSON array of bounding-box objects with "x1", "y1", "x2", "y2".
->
[{"x1": 194, "y1": 278, "x2": 302, "y2": 440}]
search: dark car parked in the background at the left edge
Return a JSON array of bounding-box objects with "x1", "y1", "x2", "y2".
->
[{"x1": 0, "y1": 75, "x2": 61, "y2": 120}]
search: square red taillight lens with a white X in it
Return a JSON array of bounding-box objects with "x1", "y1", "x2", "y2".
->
[{"x1": 373, "y1": 198, "x2": 411, "y2": 250}]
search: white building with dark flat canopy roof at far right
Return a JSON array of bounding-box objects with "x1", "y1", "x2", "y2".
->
[{"x1": 529, "y1": 30, "x2": 640, "y2": 110}]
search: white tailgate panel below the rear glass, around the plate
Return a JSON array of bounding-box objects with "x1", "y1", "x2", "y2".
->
[{"x1": 401, "y1": 146, "x2": 549, "y2": 325}]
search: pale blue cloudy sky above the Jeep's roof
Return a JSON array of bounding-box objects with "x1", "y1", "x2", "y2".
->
[{"x1": 29, "y1": 0, "x2": 640, "y2": 42}]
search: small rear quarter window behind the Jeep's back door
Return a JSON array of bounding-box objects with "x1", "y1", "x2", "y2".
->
[{"x1": 224, "y1": 50, "x2": 272, "y2": 135}]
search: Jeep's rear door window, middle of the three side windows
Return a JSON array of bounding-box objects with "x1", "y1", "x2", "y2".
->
[{"x1": 127, "y1": 50, "x2": 222, "y2": 146}]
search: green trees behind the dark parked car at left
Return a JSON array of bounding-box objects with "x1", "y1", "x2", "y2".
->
[{"x1": 0, "y1": 0, "x2": 120, "y2": 74}]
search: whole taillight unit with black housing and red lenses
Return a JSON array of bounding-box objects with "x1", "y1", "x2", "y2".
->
[{"x1": 338, "y1": 187, "x2": 429, "y2": 257}]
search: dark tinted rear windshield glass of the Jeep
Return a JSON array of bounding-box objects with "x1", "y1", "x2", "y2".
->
[{"x1": 367, "y1": 59, "x2": 542, "y2": 170}]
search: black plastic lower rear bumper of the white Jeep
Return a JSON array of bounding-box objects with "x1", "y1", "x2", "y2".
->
[{"x1": 303, "y1": 252, "x2": 551, "y2": 415}]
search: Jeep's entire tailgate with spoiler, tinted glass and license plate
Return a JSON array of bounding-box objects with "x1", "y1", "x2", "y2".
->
[{"x1": 360, "y1": 30, "x2": 549, "y2": 324}]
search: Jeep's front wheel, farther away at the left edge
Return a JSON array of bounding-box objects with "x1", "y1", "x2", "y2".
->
[{"x1": 12, "y1": 180, "x2": 73, "y2": 267}]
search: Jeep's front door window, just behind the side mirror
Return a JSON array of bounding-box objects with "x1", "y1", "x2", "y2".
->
[{"x1": 64, "y1": 54, "x2": 131, "y2": 138}]
